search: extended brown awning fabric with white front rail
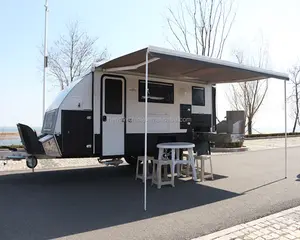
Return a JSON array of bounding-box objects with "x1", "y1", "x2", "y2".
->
[{"x1": 97, "y1": 46, "x2": 289, "y2": 84}]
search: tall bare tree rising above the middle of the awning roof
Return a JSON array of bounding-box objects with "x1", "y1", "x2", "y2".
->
[{"x1": 166, "y1": 0, "x2": 236, "y2": 58}]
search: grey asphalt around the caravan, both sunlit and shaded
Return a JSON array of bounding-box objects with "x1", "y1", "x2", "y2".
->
[{"x1": 0, "y1": 140, "x2": 300, "y2": 240}]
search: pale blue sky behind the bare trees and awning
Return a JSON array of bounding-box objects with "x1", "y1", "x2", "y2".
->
[{"x1": 0, "y1": 0, "x2": 300, "y2": 131}]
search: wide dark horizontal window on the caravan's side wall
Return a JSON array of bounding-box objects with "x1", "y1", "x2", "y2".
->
[{"x1": 139, "y1": 80, "x2": 174, "y2": 104}]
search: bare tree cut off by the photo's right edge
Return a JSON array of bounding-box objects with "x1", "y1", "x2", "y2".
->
[{"x1": 288, "y1": 65, "x2": 300, "y2": 133}]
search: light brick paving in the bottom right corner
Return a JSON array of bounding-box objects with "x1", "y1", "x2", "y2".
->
[{"x1": 193, "y1": 207, "x2": 300, "y2": 240}]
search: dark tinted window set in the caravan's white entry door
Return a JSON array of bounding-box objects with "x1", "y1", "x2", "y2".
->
[{"x1": 105, "y1": 79, "x2": 123, "y2": 114}]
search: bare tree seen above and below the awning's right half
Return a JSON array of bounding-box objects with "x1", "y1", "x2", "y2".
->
[{"x1": 227, "y1": 46, "x2": 268, "y2": 135}]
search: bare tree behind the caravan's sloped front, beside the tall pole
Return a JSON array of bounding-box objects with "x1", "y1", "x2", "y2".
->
[{"x1": 48, "y1": 22, "x2": 107, "y2": 90}]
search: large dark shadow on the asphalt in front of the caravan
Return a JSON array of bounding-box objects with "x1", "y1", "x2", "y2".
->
[{"x1": 0, "y1": 166, "x2": 239, "y2": 239}]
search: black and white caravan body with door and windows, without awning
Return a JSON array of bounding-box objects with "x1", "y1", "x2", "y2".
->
[{"x1": 17, "y1": 71, "x2": 213, "y2": 159}]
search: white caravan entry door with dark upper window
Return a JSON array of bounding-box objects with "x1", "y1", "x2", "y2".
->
[{"x1": 102, "y1": 77, "x2": 125, "y2": 156}]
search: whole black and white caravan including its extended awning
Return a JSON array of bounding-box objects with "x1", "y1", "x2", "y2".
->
[{"x1": 17, "y1": 46, "x2": 288, "y2": 168}]
